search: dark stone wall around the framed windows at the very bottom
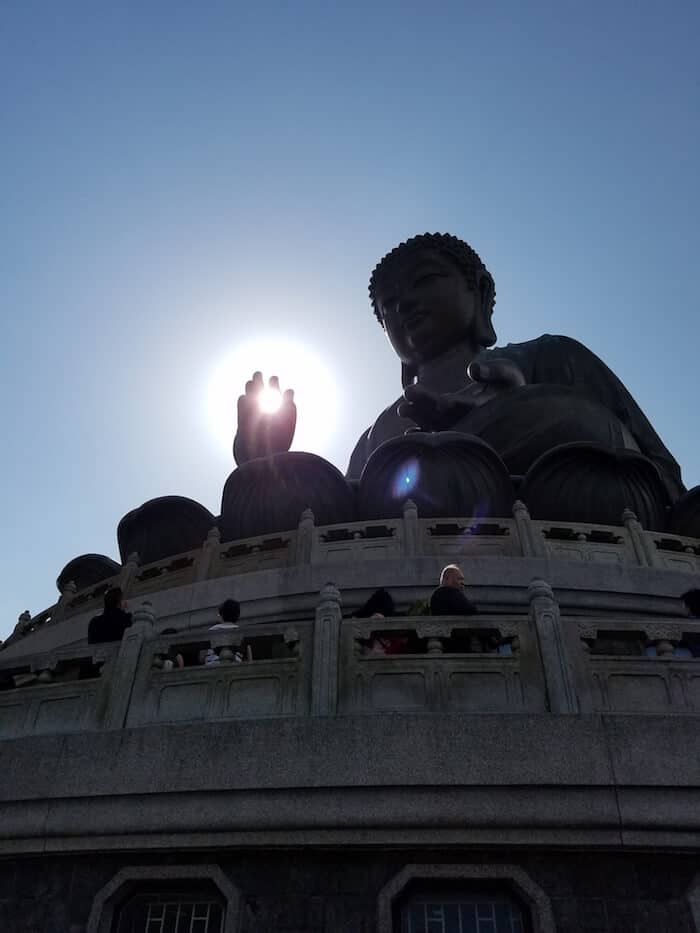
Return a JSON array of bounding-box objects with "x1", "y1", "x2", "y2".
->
[{"x1": 0, "y1": 849, "x2": 700, "y2": 933}]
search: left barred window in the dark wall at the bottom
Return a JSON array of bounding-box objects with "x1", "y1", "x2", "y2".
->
[{"x1": 114, "y1": 892, "x2": 224, "y2": 933}]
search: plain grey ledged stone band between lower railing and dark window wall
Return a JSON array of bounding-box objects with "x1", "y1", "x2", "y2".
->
[{"x1": 0, "y1": 714, "x2": 700, "y2": 852}]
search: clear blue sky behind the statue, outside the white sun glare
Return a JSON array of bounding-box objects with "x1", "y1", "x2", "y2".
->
[{"x1": 0, "y1": 0, "x2": 700, "y2": 637}]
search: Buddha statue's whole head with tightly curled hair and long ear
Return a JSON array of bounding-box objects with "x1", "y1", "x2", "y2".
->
[{"x1": 369, "y1": 233, "x2": 496, "y2": 382}]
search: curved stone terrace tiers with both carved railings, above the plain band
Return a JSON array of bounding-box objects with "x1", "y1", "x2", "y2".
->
[{"x1": 0, "y1": 501, "x2": 700, "y2": 738}]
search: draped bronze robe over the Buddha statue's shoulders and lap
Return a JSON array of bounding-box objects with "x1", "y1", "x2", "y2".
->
[{"x1": 347, "y1": 334, "x2": 684, "y2": 502}]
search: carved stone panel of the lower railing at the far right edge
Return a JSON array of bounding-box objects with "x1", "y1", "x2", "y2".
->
[{"x1": 566, "y1": 619, "x2": 700, "y2": 713}]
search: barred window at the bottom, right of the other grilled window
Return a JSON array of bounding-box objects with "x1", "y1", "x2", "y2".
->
[{"x1": 400, "y1": 893, "x2": 527, "y2": 933}]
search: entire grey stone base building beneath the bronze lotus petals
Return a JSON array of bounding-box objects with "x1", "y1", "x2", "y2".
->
[{"x1": 0, "y1": 503, "x2": 700, "y2": 933}]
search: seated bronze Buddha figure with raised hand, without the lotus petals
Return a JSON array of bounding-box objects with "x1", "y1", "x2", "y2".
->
[{"x1": 235, "y1": 234, "x2": 683, "y2": 510}]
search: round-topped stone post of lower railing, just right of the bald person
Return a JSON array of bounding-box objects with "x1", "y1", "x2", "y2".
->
[{"x1": 527, "y1": 578, "x2": 579, "y2": 713}]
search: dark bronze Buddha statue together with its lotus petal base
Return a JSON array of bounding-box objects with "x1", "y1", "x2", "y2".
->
[{"x1": 38, "y1": 233, "x2": 700, "y2": 591}]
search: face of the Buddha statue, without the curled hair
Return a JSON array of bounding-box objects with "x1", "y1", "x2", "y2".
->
[{"x1": 375, "y1": 249, "x2": 477, "y2": 365}]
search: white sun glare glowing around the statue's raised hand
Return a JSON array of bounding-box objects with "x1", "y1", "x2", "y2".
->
[{"x1": 206, "y1": 336, "x2": 336, "y2": 455}]
